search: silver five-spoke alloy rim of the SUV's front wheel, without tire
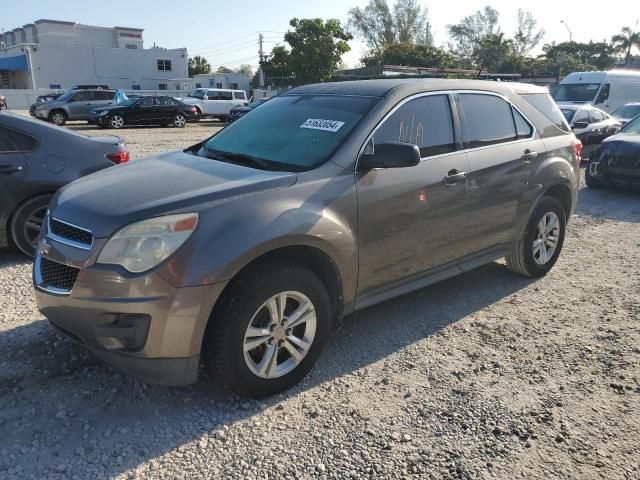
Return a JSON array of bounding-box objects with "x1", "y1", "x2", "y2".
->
[{"x1": 243, "y1": 291, "x2": 317, "y2": 379}]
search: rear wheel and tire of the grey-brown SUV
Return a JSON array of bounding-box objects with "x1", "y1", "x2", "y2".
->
[{"x1": 506, "y1": 197, "x2": 567, "y2": 277}]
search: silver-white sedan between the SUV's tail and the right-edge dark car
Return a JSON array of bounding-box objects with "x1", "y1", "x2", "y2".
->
[{"x1": 560, "y1": 105, "x2": 622, "y2": 159}]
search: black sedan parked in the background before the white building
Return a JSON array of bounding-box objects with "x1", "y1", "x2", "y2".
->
[{"x1": 89, "y1": 97, "x2": 198, "y2": 128}]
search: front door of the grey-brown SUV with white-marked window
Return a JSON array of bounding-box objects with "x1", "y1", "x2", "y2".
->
[{"x1": 356, "y1": 94, "x2": 469, "y2": 295}]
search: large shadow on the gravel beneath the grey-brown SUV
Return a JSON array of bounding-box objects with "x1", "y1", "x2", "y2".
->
[{"x1": 0, "y1": 263, "x2": 533, "y2": 478}]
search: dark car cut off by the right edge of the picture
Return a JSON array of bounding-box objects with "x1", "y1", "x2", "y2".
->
[{"x1": 584, "y1": 115, "x2": 640, "y2": 188}]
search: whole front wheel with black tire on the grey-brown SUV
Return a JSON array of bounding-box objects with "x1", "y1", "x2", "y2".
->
[{"x1": 203, "y1": 263, "x2": 332, "y2": 398}]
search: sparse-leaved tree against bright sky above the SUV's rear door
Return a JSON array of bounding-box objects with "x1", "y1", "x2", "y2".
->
[{"x1": 447, "y1": 5, "x2": 500, "y2": 62}]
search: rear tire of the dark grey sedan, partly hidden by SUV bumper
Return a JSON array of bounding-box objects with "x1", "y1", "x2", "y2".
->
[{"x1": 9, "y1": 195, "x2": 51, "y2": 257}]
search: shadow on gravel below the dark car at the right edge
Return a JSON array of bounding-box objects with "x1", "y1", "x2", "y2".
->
[{"x1": 576, "y1": 187, "x2": 640, "y2": 223}]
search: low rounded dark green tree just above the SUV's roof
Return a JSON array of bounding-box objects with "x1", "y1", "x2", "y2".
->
[{"x1": 362, "y1": 43, "x2": 456, "y2": 68}]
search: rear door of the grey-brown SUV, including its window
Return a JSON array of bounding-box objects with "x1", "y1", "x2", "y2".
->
[{"x1": 458, "y1": 92, "x2": 545, "y2": 253}]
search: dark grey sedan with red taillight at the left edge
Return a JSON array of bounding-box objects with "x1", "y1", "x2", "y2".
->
[{"x1": 0, "y1": 113, "x2": 129, "y2": 256}]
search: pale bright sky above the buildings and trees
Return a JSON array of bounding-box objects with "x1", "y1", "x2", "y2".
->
[{"x1": 0, "y1": 0, "x2": 640, "y2": 69}]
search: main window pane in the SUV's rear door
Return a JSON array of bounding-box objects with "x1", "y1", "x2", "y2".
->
[{"x1": 460, "y1": 93, "x2": 518, "y2": 148}]
